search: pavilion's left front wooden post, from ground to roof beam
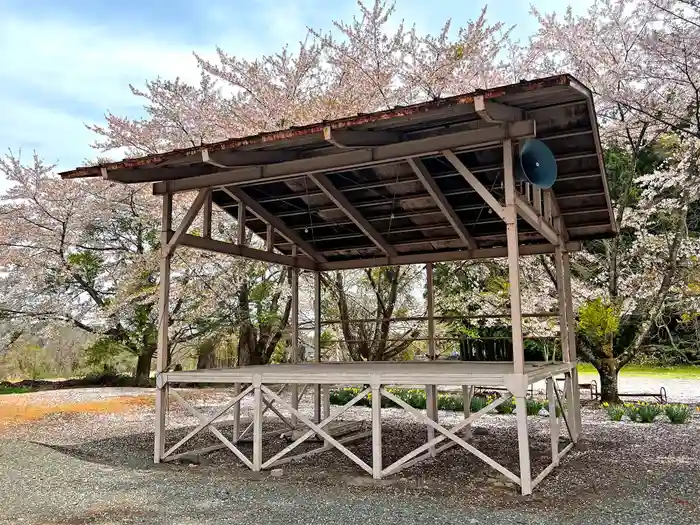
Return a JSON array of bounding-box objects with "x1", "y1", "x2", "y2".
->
[{"x1": 153, "y1": 194, "x2": 173, "y2": 463}]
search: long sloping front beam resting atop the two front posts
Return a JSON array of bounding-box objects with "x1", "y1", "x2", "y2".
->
[{"x1": 153, "y1": 120, "x2": 535, "y2": 195}]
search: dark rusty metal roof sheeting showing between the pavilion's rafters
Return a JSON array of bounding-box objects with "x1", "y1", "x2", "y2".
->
[{"x1": 61, "y1": 75, "x2": 615, "y2": 261}]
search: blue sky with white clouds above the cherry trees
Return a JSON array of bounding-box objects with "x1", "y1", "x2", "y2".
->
[{"x1": 0, "y1": 0, "x2": 590, "y2": 186}]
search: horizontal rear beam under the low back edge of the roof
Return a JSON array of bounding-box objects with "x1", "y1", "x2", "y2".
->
[{"x1": 316, "y1": 241, "x2": 581, "y2": 271}]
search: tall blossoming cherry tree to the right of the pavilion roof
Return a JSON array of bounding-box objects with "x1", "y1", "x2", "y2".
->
[{"x1": 532, "y1": 0, "x2": 700, "y2": 401}]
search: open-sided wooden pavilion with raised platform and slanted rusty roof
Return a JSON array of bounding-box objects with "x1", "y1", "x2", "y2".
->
[{"x1": 61, "y1": 71, "x2": 616, "y2": 494}]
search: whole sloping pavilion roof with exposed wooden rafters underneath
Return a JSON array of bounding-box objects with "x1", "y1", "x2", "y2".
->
[{"x1": 62, "y1": 75, "x2": 616, "y2": 270}]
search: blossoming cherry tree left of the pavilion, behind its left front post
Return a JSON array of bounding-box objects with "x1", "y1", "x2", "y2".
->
[{"x1": 0, "y1": 149, "x2": 243, "y2": 382}]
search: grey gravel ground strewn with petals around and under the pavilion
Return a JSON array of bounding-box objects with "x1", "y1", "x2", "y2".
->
[{"x1": 0, "y1": 387, "x2": 700, "y2": 525}]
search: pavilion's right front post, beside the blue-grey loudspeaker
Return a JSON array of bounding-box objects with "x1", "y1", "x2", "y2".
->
[{"x1": 503, "y1": 139, "x2": 532, "y2": 495}]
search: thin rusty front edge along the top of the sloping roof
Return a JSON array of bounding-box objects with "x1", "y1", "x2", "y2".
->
[{"x1": 59, "y1": 73, "x2": 576, "y2": 179}]
